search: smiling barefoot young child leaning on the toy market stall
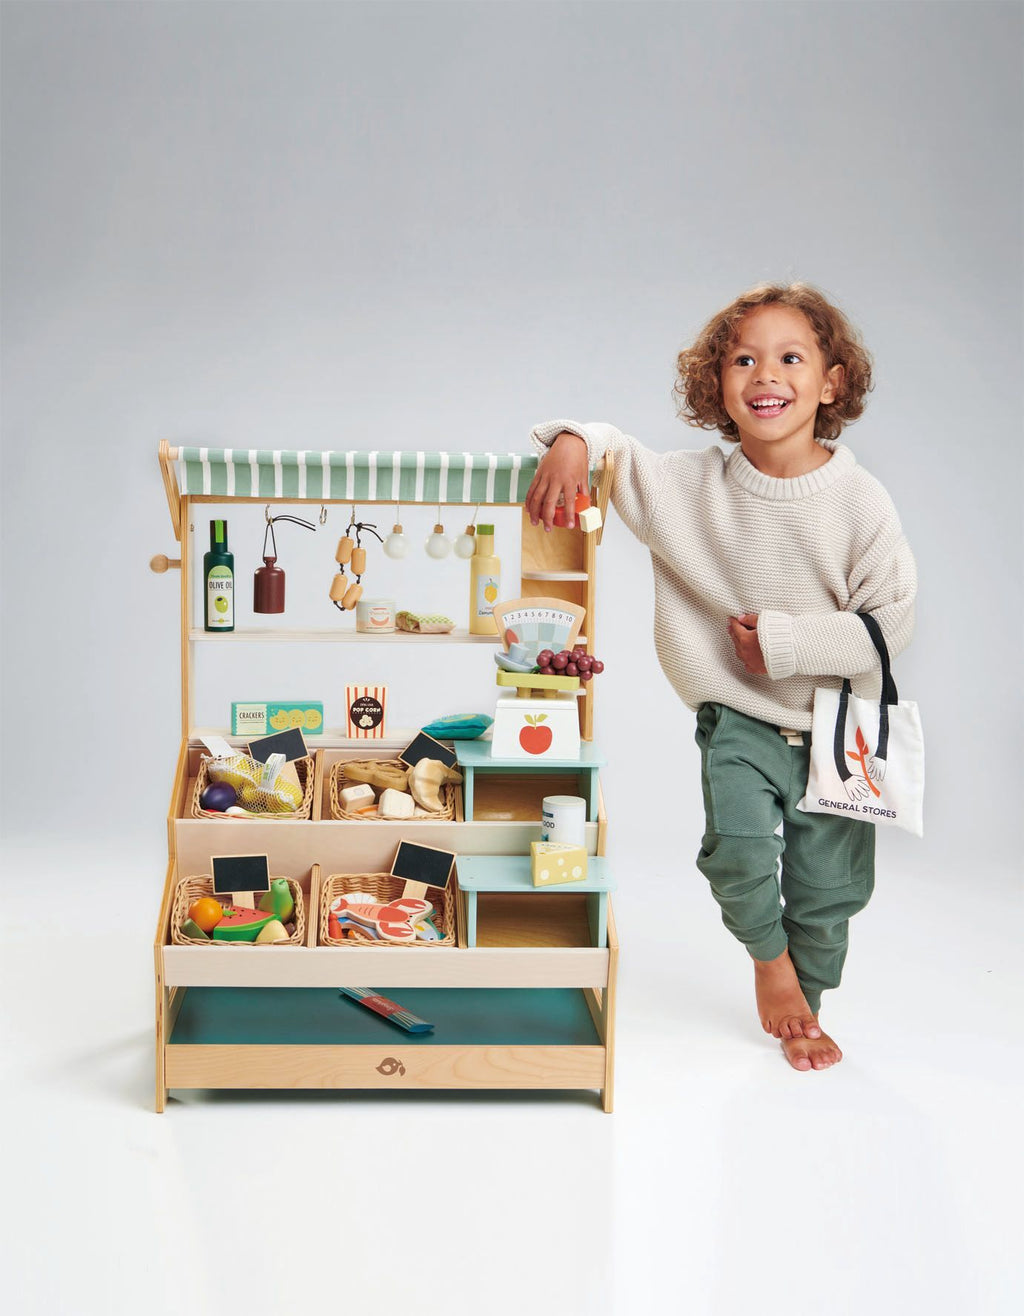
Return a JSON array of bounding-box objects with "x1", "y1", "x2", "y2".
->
[{"x1": 526, "y1": 283, "x2": 916, "y2": 1070}]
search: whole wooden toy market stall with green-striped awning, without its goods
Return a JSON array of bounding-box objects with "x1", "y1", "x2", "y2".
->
[{"x1": 151, "y1": 442, "x2": 619, "y2": 1111}]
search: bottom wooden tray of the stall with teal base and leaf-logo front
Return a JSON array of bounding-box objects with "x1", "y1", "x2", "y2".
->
[{"x1": 165, "y1": 984, "x2": 609, "y2": 1091}]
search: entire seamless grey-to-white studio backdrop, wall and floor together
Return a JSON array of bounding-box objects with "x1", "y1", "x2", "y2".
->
[{"x1": 0, "y1": 10, "x2": 1023, "y2": 1316}]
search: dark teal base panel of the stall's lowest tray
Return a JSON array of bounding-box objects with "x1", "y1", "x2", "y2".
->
[{"x1": 170, "y1": 989, "x2": 602, "y2": 1046}]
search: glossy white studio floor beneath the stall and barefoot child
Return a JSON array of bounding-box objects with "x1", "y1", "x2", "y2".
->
[{"x1": 3, "y1": 849, "x2": 1024, "y2": 1316}]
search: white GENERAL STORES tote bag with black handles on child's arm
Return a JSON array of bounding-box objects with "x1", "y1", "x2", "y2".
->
[{"x1": 796, "y1": 612, "x2": 924, "y2": 836}]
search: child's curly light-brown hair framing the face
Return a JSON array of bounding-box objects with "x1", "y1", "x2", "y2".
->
[{"x1": 673, "y1": 283, "x2": 871, "y2": 442}]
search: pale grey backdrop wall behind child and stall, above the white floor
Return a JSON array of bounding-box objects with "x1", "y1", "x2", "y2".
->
[{"x1": 3, "y1": 3, "x2": 1021, "y2": 883}]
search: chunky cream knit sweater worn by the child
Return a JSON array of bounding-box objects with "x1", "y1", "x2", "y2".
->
[{"x1": 532, "y1": 420, "x2": 917, "y2": 730}]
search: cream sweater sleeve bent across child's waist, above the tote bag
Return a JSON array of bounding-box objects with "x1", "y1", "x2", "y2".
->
[{"x1": 757, "y1": 495, "x2": 917, "y2": 680}]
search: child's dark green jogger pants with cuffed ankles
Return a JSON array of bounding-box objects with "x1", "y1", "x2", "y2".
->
[{"x1": 696, "y1": 703, "x2": 875, "y2": 1013}]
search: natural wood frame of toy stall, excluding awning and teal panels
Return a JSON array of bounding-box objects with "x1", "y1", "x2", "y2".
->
[{"x1": 151, "y1": 441, "x2": 619, "y2": 1112}]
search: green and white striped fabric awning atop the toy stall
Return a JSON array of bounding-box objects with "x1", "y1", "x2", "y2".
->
[{"x1": 178, "y1": 447, "x2": 537, "y2": 504}]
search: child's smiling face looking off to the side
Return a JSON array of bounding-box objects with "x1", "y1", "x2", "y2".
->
[{"x1": 721, "y1": 305, "x2": 842, "y2": 453}]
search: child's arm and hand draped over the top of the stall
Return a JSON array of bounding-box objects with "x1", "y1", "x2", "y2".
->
[{"x1": 526, "y1": 420, "x2": 673, "y2": 544}]
